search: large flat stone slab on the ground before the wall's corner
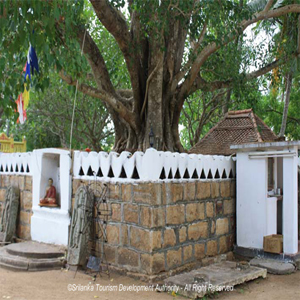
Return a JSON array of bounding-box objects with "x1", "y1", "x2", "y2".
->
[{"x1": 164, "y1": 261, "x2": 267, "y2": 299}]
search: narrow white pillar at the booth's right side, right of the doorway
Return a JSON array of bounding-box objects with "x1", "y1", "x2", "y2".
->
[{"x1": 282, "y1": 147, "x2": 298, "y2": 254}]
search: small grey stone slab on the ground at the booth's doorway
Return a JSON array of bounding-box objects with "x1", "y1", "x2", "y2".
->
[{"x1": 250, "y1": 258, "x2": 296, "y2": 275}]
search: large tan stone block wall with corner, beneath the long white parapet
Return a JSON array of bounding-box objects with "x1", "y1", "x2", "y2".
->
[{"x1": 73, "y1": 179, "x2": 235, "y2": 276}]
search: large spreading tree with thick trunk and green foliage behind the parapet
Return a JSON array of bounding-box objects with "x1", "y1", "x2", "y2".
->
[{"x1": 0, "y1": 0, "x2": 300, "y2": 151}]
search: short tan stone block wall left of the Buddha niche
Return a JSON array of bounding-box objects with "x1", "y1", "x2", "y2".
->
[{"x1": 0, "y1": 175, "x2": 32, "y2": 240}]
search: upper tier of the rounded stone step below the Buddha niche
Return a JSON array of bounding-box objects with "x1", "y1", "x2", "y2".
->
[{"x1": 5, "y1": 241, "x2": 65, "y2": 258}]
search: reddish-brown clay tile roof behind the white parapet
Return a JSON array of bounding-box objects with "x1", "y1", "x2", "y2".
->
[{"x1": 189, "y1": 109, "x2": 278, "y2": 155}]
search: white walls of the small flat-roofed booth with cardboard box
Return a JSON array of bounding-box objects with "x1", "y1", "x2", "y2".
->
[{"x1": 237, "y1": 146, "x2": 298, "y2": 254}]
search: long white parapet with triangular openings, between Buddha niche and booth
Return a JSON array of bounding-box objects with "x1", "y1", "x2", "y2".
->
[{"x1": 73, "y1": 149, "x2": 235, "y2": 181}]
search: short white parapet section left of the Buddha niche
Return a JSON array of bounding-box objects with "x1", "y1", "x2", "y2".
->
[{"x1": 0, "y1": 152, "x2": 32, "y2": 175}]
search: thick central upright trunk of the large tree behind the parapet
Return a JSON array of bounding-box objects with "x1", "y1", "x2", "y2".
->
[{"x1": 106, "y1": 16, "x2": 187, "y2": 152}]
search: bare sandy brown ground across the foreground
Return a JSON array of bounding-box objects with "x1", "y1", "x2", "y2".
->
[{"x1": 0, "y1": 269, "x2": 300, "y2": 300}]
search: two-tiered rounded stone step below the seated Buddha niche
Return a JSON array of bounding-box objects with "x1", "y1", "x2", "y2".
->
[{"x1": 0, "y1": 242, "x2": 66, "y2": 272}]
